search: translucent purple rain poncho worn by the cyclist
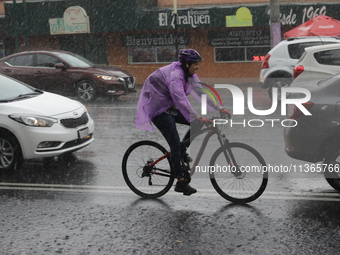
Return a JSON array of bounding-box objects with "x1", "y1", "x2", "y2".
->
[{"x1": 135, "y1": 62, "x2": 218, "y2": 130}]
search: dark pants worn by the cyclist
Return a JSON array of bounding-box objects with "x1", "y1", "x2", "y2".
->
[{"x1": 152, "y1": 110, "x2": 203, "y2": 178}]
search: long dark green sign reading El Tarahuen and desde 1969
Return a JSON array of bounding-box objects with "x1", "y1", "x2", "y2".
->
[{"x1": 145, "y1": 3, "x2": 340, "y2": 29}]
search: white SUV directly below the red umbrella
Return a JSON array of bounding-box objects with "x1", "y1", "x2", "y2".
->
[{"x1": 260, "y1": 36, "x2": 340, "y2": 98}]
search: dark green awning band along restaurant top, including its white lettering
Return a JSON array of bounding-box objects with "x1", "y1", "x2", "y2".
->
[{"x1": 5, "y1": 0, "x2": 340, "y2": 36}]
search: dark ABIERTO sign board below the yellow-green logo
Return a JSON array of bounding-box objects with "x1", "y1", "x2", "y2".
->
[{"x1": 209, "y1": 29, "x2": 270, "y2": 47}]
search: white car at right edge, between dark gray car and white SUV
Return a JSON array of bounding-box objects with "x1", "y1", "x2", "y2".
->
[{"x1": 292, "y1": 44, "x2": 340, "y2": 85}]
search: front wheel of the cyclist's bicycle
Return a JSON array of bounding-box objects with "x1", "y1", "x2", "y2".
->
[{"x1": 209, "y1": 143, "x2": 268, "y2": 203}]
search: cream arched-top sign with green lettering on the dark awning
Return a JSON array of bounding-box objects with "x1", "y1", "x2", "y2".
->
[{"x1": 49, "y1": 6, "x2": 90, "y2": 35}]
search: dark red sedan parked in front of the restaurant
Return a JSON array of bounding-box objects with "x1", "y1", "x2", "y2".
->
[{"x1": 0, "y1": 51, "x2": 135, "y2": 102}]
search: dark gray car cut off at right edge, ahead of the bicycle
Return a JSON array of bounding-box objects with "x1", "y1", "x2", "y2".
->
[{"x1": 284, "y1": 74, "x2": 340, "y2": 191}]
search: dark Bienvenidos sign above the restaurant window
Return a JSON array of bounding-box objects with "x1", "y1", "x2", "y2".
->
[{"x1": 123, "y1": 34, "x2": 189, "y2": 47}]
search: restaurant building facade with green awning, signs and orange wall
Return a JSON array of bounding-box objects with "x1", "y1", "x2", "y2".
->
[{"x1": 3, "y1": 0, "x2": 340, "y2": 84}]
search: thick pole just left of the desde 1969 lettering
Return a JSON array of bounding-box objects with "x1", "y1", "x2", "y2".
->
[{"x1": 269, "y1": 0, "x2": 281, "y2": 48}]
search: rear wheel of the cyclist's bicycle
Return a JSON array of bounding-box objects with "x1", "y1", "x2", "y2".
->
[{"x1": 122, "y1": 141, "x2": 174, "y2": 198}]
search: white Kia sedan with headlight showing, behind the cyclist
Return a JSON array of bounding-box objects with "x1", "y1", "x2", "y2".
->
[{"x1": 0, "y1": 75, "x2": 94, "y2": 172}]
